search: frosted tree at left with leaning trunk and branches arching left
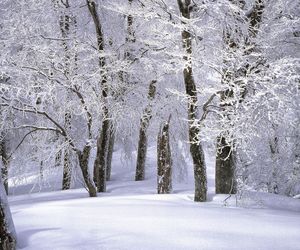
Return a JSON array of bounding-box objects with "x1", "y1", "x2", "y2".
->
[{"x1": 1, "y1": 1, "x2": 97, "y2": 196}]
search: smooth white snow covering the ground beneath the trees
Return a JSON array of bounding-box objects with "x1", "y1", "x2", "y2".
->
[{"x1": 9, "y1": 148, "x2": 300, "y2": 250}]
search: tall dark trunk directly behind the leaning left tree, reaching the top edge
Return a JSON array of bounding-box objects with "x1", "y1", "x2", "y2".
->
[{"x1": 86, "y1": 0, "x2": 111, "y2": 192}]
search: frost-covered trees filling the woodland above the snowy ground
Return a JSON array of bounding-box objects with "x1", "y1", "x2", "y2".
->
[{"x1": 0, "y1": 0, "x2": 300, "y2": 240}]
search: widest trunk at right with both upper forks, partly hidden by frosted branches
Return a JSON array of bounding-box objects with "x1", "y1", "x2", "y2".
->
[{"x1": 215, "y1": 0, "x2": 265, "y2": 194}]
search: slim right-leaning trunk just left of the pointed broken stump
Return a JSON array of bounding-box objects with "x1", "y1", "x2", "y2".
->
[{"x1": 135, "y1": 80, "x2": 156, "y2": 181}]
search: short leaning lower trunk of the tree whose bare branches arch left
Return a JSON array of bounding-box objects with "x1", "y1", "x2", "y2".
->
[{"x1": 77, "y1": 145, "x2": 97, "y2": 197}]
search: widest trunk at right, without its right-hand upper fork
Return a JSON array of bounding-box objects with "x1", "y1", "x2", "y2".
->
[{"x1": 215, "y1": 0, "x2": 245, "y2": 194}]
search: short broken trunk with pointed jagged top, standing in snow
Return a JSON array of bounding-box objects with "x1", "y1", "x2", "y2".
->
[{"x1": 157, "y1": 116, "x2": 172, "y2": 194}]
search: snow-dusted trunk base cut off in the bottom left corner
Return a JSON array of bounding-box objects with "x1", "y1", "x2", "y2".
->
[{"x1": 0, "y1": 178, "x2": 17, "y2": 250}]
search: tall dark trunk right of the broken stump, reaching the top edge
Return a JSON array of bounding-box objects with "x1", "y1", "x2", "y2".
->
[{"x1": 177, "y1": 0, "x2": 207, "y2": 201}]
